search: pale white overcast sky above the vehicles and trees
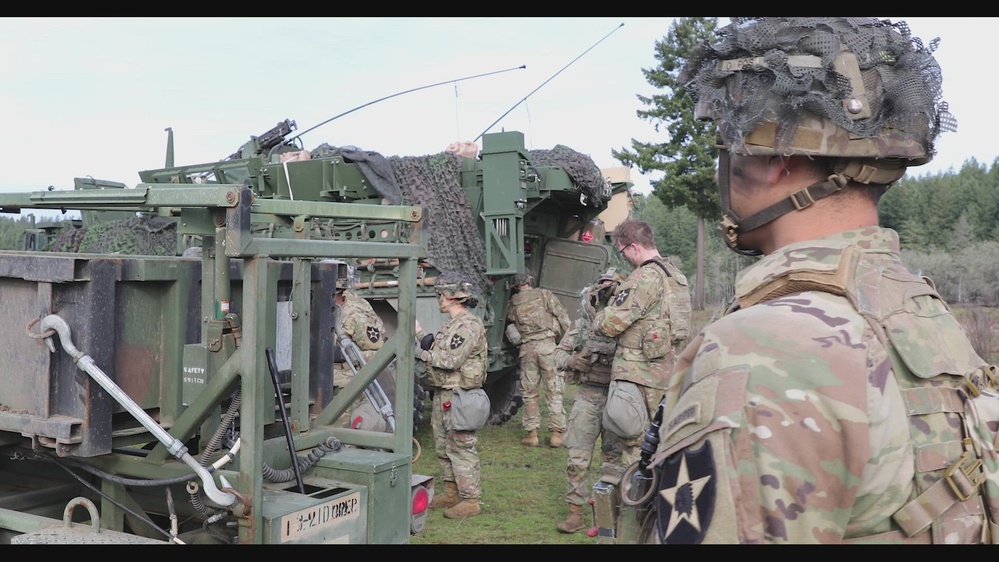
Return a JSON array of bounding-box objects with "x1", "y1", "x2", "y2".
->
[{"x1": 0, "y1": 17, "x2": 999, "y2": 206}]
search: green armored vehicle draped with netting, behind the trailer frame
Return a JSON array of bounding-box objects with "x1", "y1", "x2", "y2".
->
[{"x1": 35, "y1": 120, "x2": 634, "y2": 426}]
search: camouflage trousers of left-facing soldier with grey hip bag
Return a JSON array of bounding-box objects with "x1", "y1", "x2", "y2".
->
[{"x1": 430, "y1": 390, "x2": 482, "y2": 499}]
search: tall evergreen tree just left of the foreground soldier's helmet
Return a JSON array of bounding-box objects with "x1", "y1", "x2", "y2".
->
[{"x1": 611, "y1": 17, "x2": 721, "y2": 309}]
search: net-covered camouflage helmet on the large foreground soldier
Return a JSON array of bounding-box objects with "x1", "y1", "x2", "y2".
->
[{"x1": 679, "y1": 17, "x2": 957, "y2": 179}]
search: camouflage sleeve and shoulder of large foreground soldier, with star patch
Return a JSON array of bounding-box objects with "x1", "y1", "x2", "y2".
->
[{"x1": 653, "y1": 293, "x2": 900, "y2": 543}]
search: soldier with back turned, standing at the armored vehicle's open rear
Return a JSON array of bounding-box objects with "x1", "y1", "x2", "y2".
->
[{"x1": 506, "y1": 268, "x2": 570, "y2": 447}]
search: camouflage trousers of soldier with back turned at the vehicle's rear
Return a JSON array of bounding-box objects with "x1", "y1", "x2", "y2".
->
[{"x1": 520, "y1": 339, "x2": 565, "y2": 432}]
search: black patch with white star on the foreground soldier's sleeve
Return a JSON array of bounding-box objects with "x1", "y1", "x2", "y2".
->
[{"x1": 656, "y1": 442, "x2": 717, "y2": 544}]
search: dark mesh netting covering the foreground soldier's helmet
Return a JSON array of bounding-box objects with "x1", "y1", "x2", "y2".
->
[{"x1": 680, "y1": 17, "x2": 957, "y2": 157}]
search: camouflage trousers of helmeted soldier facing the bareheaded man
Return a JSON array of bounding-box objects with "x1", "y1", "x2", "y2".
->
[{"x1": 564, "y1": 383, "x2": 627, "y2": 505}]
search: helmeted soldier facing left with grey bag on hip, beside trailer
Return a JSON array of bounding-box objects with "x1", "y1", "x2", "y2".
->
[{"x1": 416, "y1": 272, "x2": 488, "y2": 519}]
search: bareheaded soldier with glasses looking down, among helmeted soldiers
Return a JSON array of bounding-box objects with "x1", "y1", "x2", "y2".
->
[{"x1": 593, "y1": 219, "x2": 690, "y2": 468}]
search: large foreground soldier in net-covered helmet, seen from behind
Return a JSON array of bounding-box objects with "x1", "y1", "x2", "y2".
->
[{"x1": 649, "y1": 18, "x2": 990, "y2": 544}]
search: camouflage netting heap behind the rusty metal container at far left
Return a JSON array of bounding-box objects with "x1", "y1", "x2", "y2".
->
[{"x1": 50, "y1": 216, "x2": 177, "y2": 256}]
